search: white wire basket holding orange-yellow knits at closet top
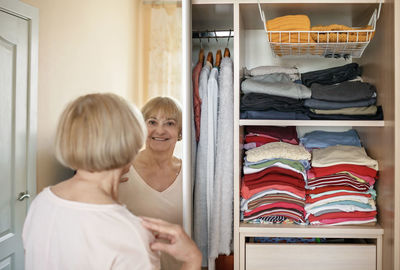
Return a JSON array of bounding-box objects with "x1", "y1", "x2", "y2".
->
[{"x1": 258, "y1": 1, "x2": 382, "y2": 58}]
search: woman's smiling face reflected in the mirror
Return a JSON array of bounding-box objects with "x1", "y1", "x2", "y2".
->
[{"x1": 146, "y1": 111, "x2": 179, "y2": 153}]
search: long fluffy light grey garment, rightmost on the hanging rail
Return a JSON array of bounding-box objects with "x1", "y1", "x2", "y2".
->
[{"x1": 209, "y1": 57, "x2": 233, "y2": 270}]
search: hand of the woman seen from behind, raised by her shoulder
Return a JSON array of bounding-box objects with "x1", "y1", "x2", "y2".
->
[{"x1": 141, "y1": 217, "x2": 201, "y2": 270}]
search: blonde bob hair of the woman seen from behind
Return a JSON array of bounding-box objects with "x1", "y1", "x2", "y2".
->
[{"x1": 55, "y1": 94, "x2": 146, "y2": 172}]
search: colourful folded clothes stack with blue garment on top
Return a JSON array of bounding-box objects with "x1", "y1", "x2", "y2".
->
[{"x1": 300, "y1": 130, "x2": 378, "y2": 225}]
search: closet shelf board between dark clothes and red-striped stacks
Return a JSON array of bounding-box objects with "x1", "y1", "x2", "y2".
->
[{"x1": 239, "y1": 119, "x2": 385, "y2": 127}]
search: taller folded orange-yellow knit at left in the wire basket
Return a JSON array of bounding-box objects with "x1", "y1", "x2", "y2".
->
[{"x1": 266, "y1": 15, "x2": 315, "y2": 43}]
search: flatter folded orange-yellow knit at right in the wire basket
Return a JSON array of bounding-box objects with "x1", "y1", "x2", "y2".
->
[{"x1": 311, "y1": 24, "x2": 375, "y2": 43}]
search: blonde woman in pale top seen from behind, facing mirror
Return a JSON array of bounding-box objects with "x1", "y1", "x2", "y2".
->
[{"x1": 23, "y1": 94, "x2": 201, "y2": 270}]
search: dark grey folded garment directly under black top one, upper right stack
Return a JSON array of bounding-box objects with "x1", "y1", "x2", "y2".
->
[{"x1": 311, "y1": 81, "x2": 376, "y2": 102}]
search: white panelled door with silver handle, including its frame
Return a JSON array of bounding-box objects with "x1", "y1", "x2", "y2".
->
[{"x1": 0, "y1": 2, "x2": 36, "y2": 270}]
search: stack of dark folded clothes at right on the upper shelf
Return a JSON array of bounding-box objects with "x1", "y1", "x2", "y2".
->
[{"x1": 301, "y1": 63, "x2": 383, "y2": 120}]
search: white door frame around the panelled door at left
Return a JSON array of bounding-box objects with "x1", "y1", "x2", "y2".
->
[{"x1": 0, "y1": 0, "x2": 39, "y2": 204}]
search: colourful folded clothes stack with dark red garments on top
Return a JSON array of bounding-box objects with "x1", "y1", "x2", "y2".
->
[{"x1": 241, "y1": 127, "x2": 311, "y2": 224}]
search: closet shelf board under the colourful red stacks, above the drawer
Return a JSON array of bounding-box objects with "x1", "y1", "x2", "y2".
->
[{"x1": 239, "y1": 223, "x2": 383, "y2": 238}]
